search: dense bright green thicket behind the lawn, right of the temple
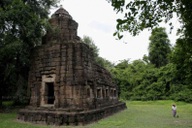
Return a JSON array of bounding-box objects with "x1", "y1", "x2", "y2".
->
[{"x1": 111, "y1": 60, "x2": 188, "y2": 102}]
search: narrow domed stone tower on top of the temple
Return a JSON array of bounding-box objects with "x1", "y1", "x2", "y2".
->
[{"x1": 43, "y1": 8, "x2": 80, "y2": 44}]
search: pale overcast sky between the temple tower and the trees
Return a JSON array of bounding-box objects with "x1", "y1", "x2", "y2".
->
[{"x1": 51, "y1": 0, "x2": 179, "y2": 63}]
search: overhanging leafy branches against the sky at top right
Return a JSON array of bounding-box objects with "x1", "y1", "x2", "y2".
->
[{"x1": 107, "y1": 0, "x2": 192, "y2": 38}]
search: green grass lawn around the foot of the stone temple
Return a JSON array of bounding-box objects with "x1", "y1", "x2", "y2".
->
[{"x1": 0, "y1": 101, "x2": 192, "y2": 128}]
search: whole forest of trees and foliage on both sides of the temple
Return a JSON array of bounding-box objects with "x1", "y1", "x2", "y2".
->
[{"x1": 0, "y1": 0, "x2": 192, "y2": 107}]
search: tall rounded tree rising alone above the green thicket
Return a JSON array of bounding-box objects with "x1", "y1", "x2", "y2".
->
[{"x1": 148, "y1": 27, "x2": 171, "y2": 68}]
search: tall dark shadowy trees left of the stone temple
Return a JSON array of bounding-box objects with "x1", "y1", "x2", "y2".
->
[{"x1": 0, "y1": 0, "x2": 58, "y2": 104}]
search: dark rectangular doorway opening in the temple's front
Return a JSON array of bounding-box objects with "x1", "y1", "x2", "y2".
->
[{"x1": 46, "y1": 83, "x2": 55, "y2": 104}]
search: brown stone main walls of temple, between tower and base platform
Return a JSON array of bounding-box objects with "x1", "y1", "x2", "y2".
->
[{"x1": 29, "y1": 41, "x2": 117, "y2": 109}]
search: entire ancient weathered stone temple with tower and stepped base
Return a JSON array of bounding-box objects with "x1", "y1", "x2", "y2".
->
[{"x1": 18, "y1": 7, "x2": 126, "y2": 125}]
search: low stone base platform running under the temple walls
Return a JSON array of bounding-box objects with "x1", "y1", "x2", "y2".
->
[{"x1": 18, "y1": 102, "x2": 126, "y2": 125}]
